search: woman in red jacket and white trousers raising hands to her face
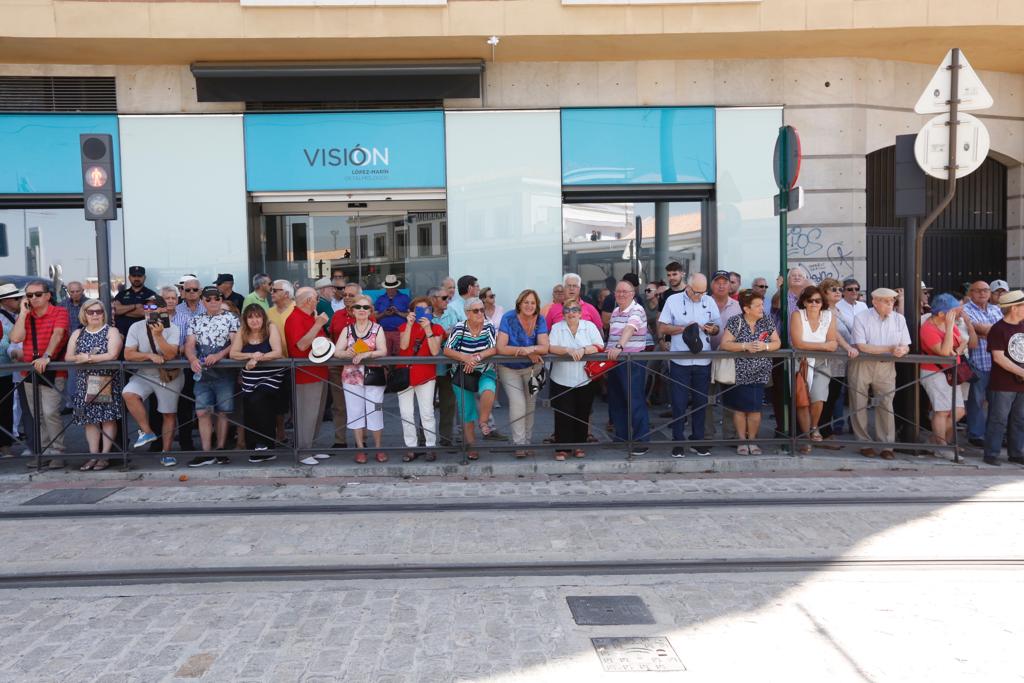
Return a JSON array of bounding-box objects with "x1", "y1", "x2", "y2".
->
[{"x1": 393, "y1": 297, "x2": 444, "y2": 463}]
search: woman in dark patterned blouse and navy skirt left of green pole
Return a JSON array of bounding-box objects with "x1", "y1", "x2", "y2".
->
[{"x1": 719, "y1": 290, "x2": 782, "y2": 456}]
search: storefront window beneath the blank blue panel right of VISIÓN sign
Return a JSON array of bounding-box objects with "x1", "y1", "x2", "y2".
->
[{"x1": 562, "y1": 202, "x2": 703, "y2": 298}]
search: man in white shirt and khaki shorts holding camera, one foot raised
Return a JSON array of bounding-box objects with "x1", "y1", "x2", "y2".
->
[{"x1": 122, "y1": 287, "x2": 185, "y2": 467}]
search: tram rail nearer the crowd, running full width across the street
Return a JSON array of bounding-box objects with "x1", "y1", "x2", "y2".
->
[{"x1": 0, "y1": 496, "x2": 1024, "y2": 521}]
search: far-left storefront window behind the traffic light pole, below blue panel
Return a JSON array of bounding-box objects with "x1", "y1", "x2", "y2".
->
[{"x1": 0, "y1": 209, "x2": 125, "y2": 297}]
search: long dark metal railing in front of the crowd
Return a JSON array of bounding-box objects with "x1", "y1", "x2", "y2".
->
[{"x1": 0, "y1": 349, "x2": 959, "y2": 470}]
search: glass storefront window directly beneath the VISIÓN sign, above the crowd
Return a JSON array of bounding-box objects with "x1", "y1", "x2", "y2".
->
[{"x1": 251, "y1": 206, "x2": 447, "y2": 294}]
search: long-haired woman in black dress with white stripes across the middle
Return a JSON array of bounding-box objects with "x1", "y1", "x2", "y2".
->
[{"x1": 230, "y1": 303, "x2": 288, "y2": 463}]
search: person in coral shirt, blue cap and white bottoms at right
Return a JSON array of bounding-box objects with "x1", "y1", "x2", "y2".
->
[{"x1": 921, "y1": 294, "x2": 970, "y2": 458}]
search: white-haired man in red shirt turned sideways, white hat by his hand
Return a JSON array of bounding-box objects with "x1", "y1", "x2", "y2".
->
[{"x1": 285, "y1": 287, "x2": 329, "y2": 465}]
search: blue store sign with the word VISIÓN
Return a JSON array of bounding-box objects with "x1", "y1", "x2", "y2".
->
[{"x1": 245, "y1": 112, "x2": 444, "y2": 191}]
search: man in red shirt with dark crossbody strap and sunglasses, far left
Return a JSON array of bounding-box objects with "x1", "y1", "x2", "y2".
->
[{"x1": 10, "y1": 280, "x2": 71, "y2": 469}]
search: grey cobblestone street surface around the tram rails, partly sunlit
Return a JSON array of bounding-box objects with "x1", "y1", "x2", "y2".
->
[{"x1": 0, "y1": 474, "x2": 1024, "y2": 683}]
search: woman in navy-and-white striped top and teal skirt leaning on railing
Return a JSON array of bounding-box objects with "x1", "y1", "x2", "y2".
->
[{"x1": 444, "y1": 297, "x2": 498, "y2": 460}]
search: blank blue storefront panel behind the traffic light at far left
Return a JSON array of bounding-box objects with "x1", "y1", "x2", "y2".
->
[{"x1": 0, "y1": 114, "x2": 121, "y2": 195}]
